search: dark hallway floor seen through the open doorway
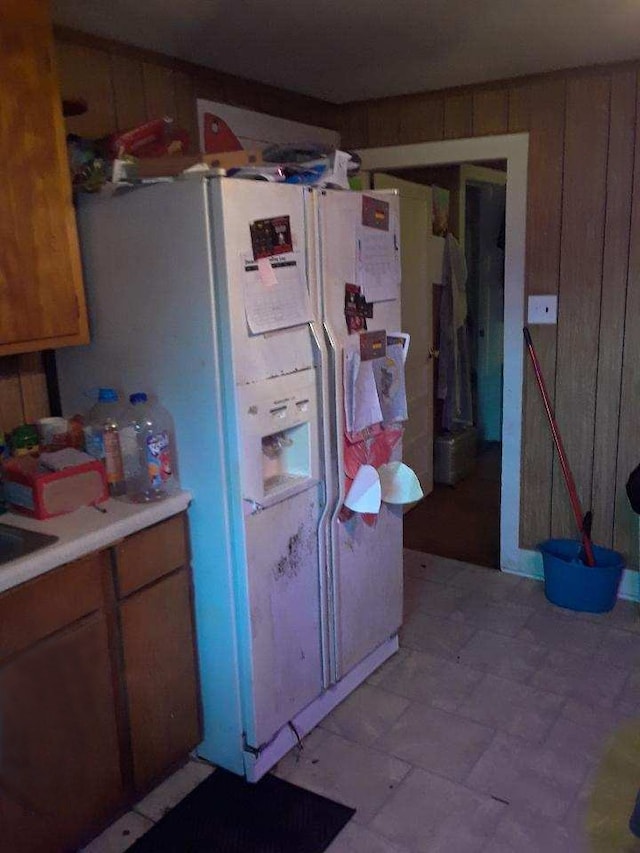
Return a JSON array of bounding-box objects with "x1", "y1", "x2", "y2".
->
[{"x1": 404, "y1": 443, "x2": 501, "y2": 569}]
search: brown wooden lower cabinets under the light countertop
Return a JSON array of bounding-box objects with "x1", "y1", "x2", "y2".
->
[{"x1": 0, "y1": 515, "x2": 200, "y2": 853}]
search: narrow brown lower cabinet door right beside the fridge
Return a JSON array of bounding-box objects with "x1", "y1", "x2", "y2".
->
[{"x1": 120, "y1": 569, "x2": 200, "y2": 792}]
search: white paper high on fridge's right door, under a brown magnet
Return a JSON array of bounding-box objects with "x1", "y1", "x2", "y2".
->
[{"x1": 356, "y1": 226, "x2": 401, "y2": 302}]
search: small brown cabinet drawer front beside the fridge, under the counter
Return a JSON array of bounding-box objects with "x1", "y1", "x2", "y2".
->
[{"x1": 116, "y1": 515, "x2": 189, "y2": 598}]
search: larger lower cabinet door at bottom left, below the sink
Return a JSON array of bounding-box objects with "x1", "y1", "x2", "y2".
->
[{"x1": 0, "y1": 614, "x2": 123, "y2": 853}]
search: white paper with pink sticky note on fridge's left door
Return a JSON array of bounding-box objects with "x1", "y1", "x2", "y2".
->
[{"x1": 243, "y1": 252, "x2": 313, "y2": 335}]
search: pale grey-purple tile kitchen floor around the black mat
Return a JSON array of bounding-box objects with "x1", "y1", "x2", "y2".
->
[{"x1": 85, "y1": 551, "x2": 640, "y2": 853}]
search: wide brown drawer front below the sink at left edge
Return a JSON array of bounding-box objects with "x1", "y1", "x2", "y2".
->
[{"x1": 0, "y1": 551, "x2": 109, "y2": 661}]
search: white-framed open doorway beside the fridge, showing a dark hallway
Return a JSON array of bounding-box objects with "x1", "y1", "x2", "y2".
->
[{"x1": 373, "y1": 161, "x2": 506, "y2": 569}]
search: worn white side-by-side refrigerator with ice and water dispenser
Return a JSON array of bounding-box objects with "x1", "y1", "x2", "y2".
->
[{"x1": 57, "y1": 178, "x2": 402, "y2": 780}]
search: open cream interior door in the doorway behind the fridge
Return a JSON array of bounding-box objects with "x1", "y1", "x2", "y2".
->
[{"x1": 373, "y1": 174, "x2": 434, "y2": 495}]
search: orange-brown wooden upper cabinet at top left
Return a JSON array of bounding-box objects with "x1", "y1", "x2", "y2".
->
[{"x1": 0, "y1": 0, "x2": 88, "y2": 356}]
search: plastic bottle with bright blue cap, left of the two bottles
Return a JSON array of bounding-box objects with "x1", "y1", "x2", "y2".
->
[{"x1": 84, "y1": 388, "x2": 125, "y2": 497}]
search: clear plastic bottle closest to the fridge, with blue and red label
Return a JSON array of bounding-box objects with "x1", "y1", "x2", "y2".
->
[{"x1": 122, "y1": 391, "x2": 177, "y2": 503}]
